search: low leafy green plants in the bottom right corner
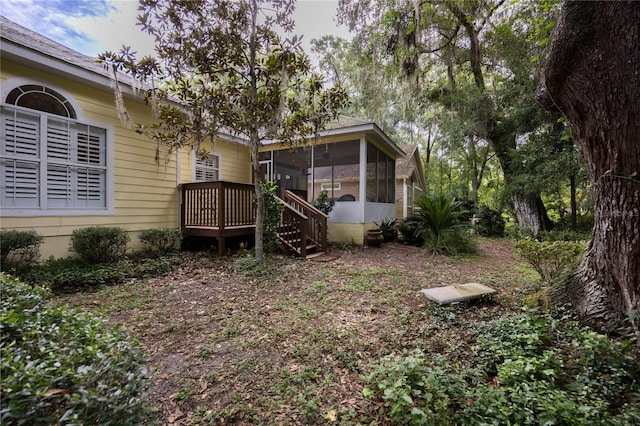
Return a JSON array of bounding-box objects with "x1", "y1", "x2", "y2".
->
[{"x1": 472, "y1": 312, "x2": 640, "y2": 424}]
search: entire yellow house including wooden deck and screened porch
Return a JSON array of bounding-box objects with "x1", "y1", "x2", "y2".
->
[{"x1": 0, "y1": 17, "x2": 416, "y2": 257}]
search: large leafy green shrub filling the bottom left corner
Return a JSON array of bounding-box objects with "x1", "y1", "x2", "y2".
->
[{"x1": 0, "y1": 274, "x2": 151, "y2": 425}]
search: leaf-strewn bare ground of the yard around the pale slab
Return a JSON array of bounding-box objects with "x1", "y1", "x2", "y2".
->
[{"x1": 56, "y1": 239, "x2": 632, "y2": 425}]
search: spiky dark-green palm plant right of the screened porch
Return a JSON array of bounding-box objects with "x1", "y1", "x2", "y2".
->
[{"x1": 405, "y1": 195, "x2": 475, "y2": 254}]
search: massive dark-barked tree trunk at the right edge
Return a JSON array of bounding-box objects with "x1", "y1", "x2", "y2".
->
[{"x1": 539, "y1": 1, "x2": 640, "y2": 332}]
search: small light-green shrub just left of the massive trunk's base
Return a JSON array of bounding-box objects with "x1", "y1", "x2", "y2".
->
[{"x1": 515, "y1": 240, "x2": 585, "y2": 284}]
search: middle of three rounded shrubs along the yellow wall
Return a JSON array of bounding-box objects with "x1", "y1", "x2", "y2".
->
[{"x1": 71, "y1": 226, "x2": 129, "y2": 263}]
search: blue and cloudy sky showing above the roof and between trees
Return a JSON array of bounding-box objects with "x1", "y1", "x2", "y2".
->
[{"x1": 0, "y1": 0, "x2": 350, "y2": 60}]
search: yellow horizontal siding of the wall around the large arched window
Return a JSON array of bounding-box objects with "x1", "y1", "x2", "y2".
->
[{"x1": 0, "y1": 59, "x2": 180, "y2": 258}]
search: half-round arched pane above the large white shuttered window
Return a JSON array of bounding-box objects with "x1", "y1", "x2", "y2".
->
[{"x1": 5, "y1": 84, "x2": 78, "y2": 119}]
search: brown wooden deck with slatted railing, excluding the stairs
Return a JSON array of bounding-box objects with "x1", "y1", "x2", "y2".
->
[{"x1": 180, "y1": 181, "x2": 256, "y2": 255}]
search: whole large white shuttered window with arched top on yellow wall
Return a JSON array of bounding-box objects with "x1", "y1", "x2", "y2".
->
[{"x1": 0, "y1": 83, "x2": 110, "y2": 216}]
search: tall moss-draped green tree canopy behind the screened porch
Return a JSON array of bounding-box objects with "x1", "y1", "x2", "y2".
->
[{"x1": 330, "y1": 0, "x2": 592, "y2": 235}]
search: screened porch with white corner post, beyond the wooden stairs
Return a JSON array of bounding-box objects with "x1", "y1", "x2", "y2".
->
[{"x1": 260, "y1": 117, "x2": 404, "y2": 244}]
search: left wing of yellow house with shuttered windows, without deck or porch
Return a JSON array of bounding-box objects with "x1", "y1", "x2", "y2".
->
[{"x1": 0, "y1": 17, "x2": 250, "y2": 258}]
